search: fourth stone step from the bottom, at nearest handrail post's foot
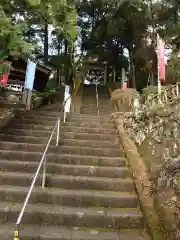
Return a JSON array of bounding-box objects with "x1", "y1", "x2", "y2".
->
[{"x1": 0, "y1": 172, "x2": 134, "y2": 192}]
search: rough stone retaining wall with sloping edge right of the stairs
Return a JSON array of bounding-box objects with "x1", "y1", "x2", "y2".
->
[{"x1": 113, "y1": 99, "x2": 180, "y2": 240}]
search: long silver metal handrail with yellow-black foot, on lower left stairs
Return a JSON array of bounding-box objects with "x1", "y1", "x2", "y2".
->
[{"x1": 14, "y1": 88, "x2": 71, "y2": 240}]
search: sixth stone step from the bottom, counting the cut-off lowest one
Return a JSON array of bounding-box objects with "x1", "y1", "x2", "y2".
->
[{"x1": 0, "y1": 150, "x2": 126, "y2": 167}]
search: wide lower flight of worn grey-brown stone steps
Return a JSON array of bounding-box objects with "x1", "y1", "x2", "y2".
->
[{"x1": 0, "y1": 88, "x2": 149, "y2": 240}]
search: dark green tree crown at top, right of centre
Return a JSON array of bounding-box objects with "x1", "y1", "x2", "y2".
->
[{"x1": 78, "y1": 0, "x2": 151, "y2": 86}]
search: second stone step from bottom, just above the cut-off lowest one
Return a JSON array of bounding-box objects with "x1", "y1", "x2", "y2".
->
[{"x1": 0, "y1": 202, "x2": 143, "y2": 229}]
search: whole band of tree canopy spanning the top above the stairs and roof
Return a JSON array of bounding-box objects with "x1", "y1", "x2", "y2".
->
[{"x1": 0, "y1": 0, "x2": 180, "y2": 89}]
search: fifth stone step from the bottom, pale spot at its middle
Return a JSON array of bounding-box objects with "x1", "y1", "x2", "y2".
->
[{"x1": 0, "y1": 160, "x2": 131, "y2": 178}]
